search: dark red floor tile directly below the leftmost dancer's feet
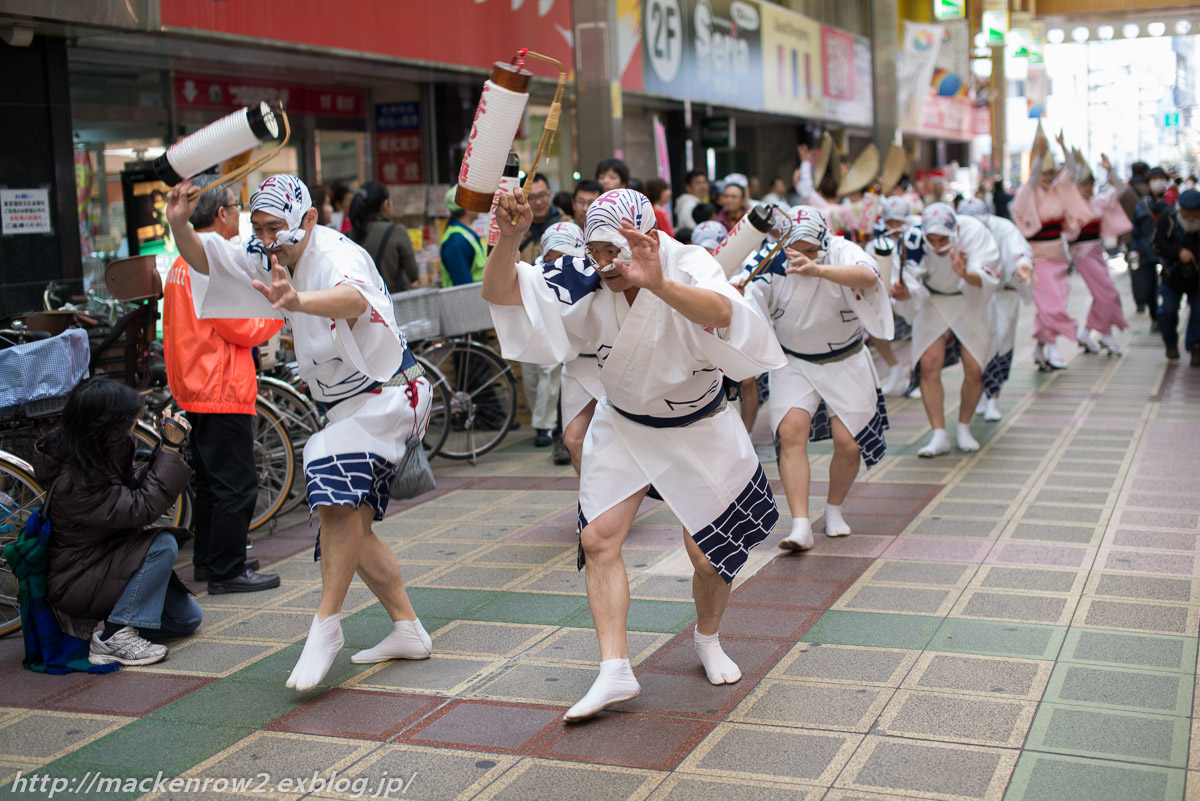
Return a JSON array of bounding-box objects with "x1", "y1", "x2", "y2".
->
[{"x1": 266, "y1": 688, "x2": 445, "y2": 740}]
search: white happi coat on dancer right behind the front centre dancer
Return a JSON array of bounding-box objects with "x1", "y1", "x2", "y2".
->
[{"x1": 746, "y1": 236, "x2": 893, "y2": 462}]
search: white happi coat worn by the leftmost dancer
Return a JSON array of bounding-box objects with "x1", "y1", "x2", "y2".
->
[{"x1": 191, "y1": 225, "x2": 432, "y2": 475}]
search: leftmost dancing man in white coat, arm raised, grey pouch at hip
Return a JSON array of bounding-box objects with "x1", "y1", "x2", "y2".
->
[{"x1": 167, "y1": 175, "x2": 432, "y2": 691}]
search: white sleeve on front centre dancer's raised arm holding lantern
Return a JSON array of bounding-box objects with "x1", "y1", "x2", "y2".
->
[{"x1": 491, "y1": 261, "x2": 595, "y2": 365}]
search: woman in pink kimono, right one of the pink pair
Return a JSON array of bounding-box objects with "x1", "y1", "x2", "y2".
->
[{"x1": 1063, "y1": 150, "x2": 1133, "y2": 356}]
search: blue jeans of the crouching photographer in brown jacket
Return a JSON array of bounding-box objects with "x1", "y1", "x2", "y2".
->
[{"x1": 108, "y1": 531, "x2": 202, "y2": 639}]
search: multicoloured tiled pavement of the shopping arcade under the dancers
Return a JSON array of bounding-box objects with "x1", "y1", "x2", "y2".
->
[{"x1": 0, "y1": 270, "x2": 1200, "y2": 801}]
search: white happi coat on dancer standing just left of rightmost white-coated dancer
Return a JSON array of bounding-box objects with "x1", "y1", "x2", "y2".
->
[{"x1": 895, "y1": 215, "x2": 1000, "y2": 367}]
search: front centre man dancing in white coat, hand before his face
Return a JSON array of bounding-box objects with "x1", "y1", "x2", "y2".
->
[{"x1": 484, "y1": 189, "x2": 785, "y2": 721}]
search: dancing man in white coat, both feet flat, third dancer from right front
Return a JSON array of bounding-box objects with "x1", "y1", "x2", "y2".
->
[{"x1": 892, "y1": 203, "x2": 1000, "y2": 457}]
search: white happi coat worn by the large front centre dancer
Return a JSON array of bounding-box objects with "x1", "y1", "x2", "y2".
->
[{"x1": 492, "y1": 233, "x2": 785, "y2": 580}]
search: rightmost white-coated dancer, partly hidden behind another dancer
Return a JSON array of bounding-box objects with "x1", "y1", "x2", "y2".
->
[{"x1": 958, "y1": 198, "x2": 1033, "y2": 422}]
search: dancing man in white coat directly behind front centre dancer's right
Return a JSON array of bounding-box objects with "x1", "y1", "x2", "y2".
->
[{"x1": 745, "y1": 206, "x2": 892, "y2": 550}]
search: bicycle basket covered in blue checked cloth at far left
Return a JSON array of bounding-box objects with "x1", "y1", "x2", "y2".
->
[{"x1": 0, "y1": 329, "x2": 91, "y2": 415}]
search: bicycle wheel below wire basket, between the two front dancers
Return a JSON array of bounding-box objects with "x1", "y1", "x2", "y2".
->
[{"x1": 421, "y1": 339, "x2": 517, "y2": 462}]
